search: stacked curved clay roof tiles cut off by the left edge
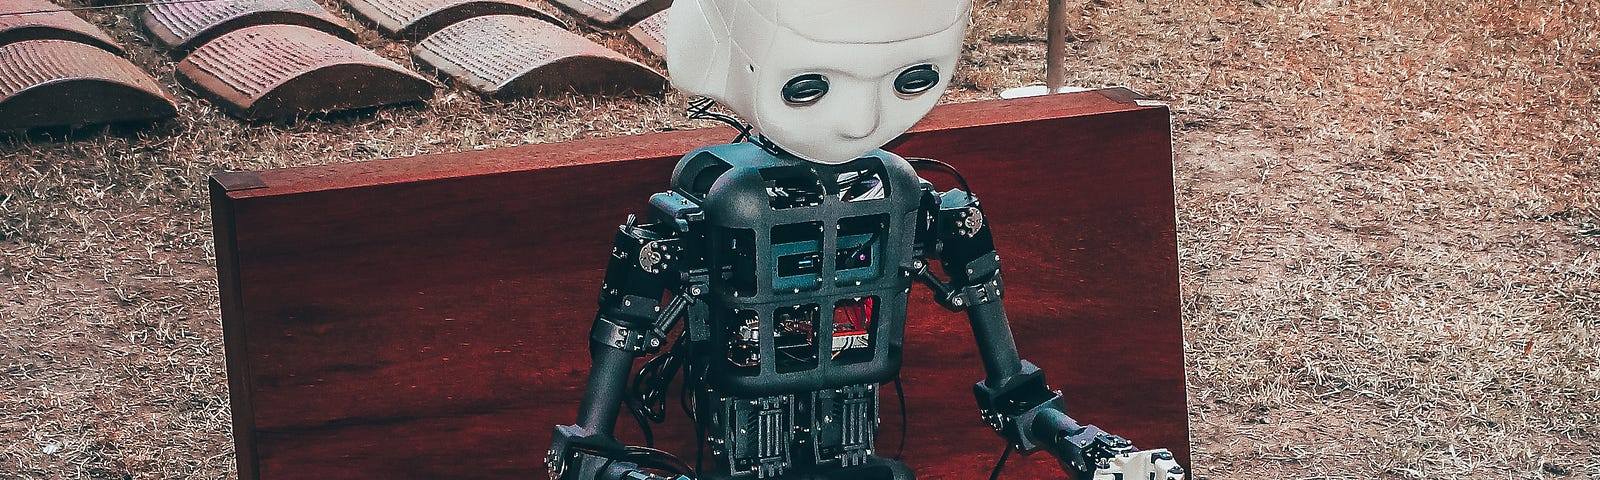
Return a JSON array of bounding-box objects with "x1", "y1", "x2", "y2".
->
[{"x1": 0, "y1": 0, "x2": 178, "y2": 128}]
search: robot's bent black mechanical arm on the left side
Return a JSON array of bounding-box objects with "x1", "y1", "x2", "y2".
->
[{"x1": 546, "y1": 200, "x2": 706, "y2": 480}]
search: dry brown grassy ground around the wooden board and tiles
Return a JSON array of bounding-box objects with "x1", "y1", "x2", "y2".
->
[{"x1": 0, "y1": 0, "x2": 1600, "y2": 478}]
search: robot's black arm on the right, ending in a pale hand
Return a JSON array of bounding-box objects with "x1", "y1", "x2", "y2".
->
[{"x1": 914, "y1": 186, "x2": 1184, "y2": 480}]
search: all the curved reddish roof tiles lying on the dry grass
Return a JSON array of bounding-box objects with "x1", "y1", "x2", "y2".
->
[{"x1": 0, "y1": 0, "x2": 670, "y2": 128}]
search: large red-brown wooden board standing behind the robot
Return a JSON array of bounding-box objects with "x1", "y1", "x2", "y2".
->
[{"x1": 213, "y1": 90, "x2": 1189, "y2": 480}]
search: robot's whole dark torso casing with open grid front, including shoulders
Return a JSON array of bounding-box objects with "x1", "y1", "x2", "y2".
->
[{"x1": 675, "y1": 146, "x2": 920, "y2": 393}]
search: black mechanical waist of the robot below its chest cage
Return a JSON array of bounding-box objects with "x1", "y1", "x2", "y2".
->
[{"x1": 706, "y1": 384, "x2": 878, "y2": 480}]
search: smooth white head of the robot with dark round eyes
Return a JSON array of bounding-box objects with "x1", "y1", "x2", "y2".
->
[{"x1": 667, "y1": 0, "x2": 971, "y2": 163}]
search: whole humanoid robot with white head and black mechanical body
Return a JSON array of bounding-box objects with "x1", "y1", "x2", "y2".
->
[{"x1": 547, "y1": 0, "x2": 1184, "y2": 480}]
